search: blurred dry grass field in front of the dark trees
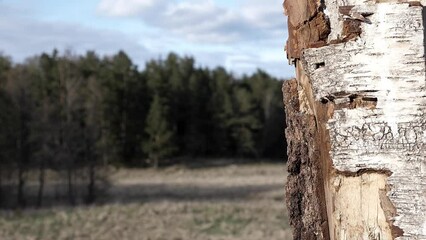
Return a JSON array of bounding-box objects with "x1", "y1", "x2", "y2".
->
[{"x1": 0, "y1": 164, "x2": 291, "y2": 240}]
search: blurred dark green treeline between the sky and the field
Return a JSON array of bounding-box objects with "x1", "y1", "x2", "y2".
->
[{"x1": 0, "y1": 50, "x2": 285, "y2": 206}]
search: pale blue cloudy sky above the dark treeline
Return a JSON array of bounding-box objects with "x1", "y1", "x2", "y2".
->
[{"x1": 0, "y1": 0, "x2": 293, "y2": 77}]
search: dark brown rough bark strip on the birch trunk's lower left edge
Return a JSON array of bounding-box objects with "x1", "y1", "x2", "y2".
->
[{"x1": 283, "y1": 80, "x2": 328, "y2": 240}]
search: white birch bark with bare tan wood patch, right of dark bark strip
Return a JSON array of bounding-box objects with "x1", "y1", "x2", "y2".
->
[{"x1": 284, "y1": 0, "x2": 426, "y2": 239}]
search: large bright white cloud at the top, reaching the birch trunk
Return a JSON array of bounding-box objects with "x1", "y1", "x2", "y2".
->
[{"x1": 98, "y1": 0, "x2": 286, "y2": 43}]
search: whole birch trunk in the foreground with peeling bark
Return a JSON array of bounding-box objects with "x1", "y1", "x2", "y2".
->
[{"x1": 283, "y1": 0, "x2": 426, "y2": 239}]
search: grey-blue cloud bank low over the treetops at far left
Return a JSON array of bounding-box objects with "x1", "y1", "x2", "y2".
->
[{"x1": 0, "y1": 12, "x2": 153, "y2": 63}]
